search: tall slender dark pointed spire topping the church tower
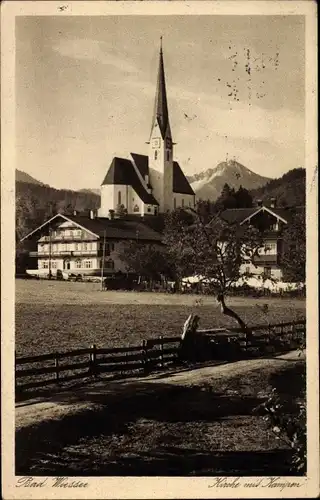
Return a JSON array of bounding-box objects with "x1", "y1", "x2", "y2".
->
[{"x1": 152, "y1": 36, "x2": 169, "y2": 138}]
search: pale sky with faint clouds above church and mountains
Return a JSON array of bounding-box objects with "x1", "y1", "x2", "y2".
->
[{"x1": 15, "y1": 15, "x2": 305, "y2": 189}]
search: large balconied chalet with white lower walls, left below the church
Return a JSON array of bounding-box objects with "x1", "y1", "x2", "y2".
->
[{"x1": 22, "y1": 214, "x2": 161, "y2": 278}]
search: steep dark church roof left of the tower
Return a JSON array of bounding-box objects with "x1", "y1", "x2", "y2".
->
[{"x1": 102, "y1": 155, "x2": 159, "y2": 205}]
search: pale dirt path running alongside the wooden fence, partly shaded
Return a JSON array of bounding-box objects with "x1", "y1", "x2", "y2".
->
[{"x1": 15, "y1": 351, "x2": 301, "y2": 431}]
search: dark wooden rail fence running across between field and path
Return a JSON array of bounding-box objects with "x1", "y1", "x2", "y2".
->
[{"x1": 15, "y1": 320, "x2": 306, "y2": 394}]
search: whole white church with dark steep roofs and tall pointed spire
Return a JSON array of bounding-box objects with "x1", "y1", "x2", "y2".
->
[{"x1": 98, "y1": 38, "x2": 195, "y2": 217}]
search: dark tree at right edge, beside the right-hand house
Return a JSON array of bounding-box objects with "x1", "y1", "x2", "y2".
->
[{"x1": 281, "y1": 210, "x2": 306, "y2": 283}]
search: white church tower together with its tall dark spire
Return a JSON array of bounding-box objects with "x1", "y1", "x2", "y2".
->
[{"x1": 148, "y1": 37, "x2": 173, "y2": 212}]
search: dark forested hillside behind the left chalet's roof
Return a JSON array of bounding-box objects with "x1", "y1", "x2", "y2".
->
[{"x1": 16, "y1": 181, "x2": 100, "y2": 241}]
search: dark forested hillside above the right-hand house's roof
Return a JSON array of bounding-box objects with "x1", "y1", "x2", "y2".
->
[{"x1": 250, "y1": 168, "x2": 306, "y2": 207}]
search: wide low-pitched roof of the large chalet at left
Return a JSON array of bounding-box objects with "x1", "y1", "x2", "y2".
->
[{"x1": 21, "y1": 214, "x2": 161, "y2": 242}]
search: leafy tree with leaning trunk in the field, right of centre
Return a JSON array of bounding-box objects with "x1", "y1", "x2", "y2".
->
[{"x1": 164, "y1": 210, "x2": 263, "y2": 332}]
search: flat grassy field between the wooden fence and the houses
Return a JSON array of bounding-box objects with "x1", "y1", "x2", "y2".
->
[{"x1": 15, "y1": 280, "x2": 305, "y2": 356}]
